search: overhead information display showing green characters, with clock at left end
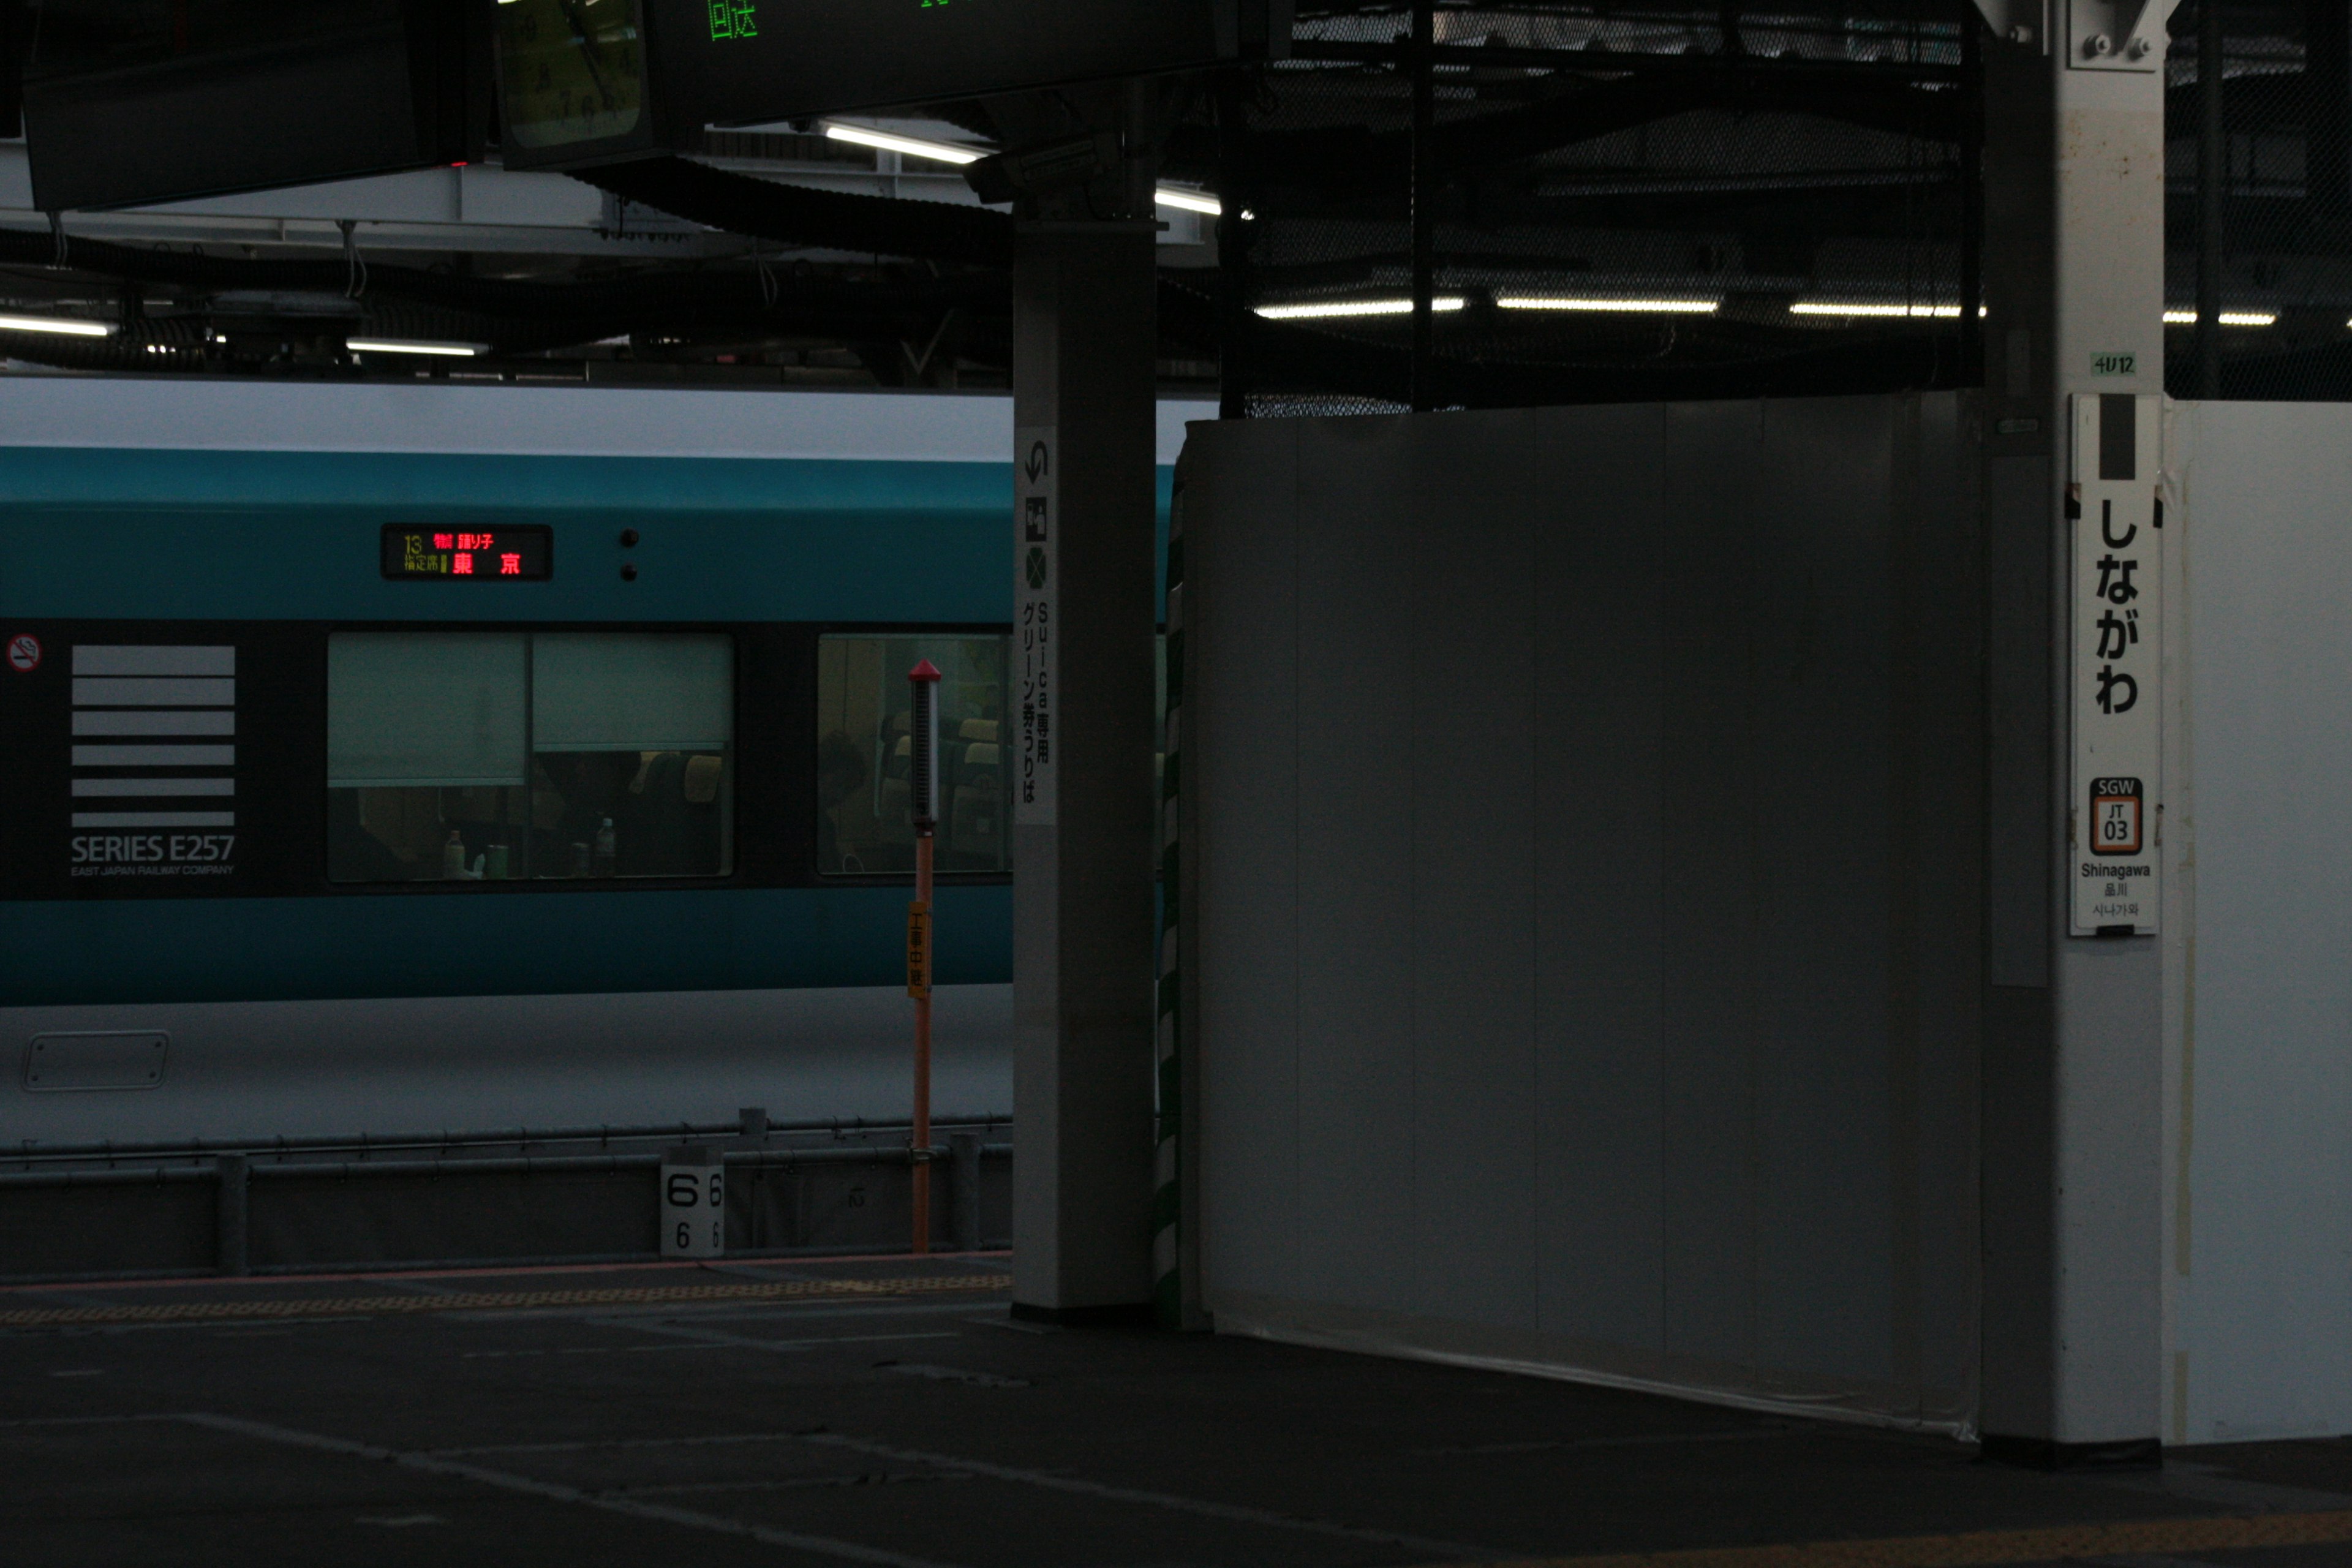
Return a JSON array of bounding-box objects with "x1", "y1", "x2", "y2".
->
[{"x1": 496, "y1": 0, "x2": 1291, "y2": 169}]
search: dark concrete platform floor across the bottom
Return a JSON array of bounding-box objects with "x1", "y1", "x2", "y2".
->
[{"x1": 13, "y1": 1257, "x2": 2352, "y2": 1568}]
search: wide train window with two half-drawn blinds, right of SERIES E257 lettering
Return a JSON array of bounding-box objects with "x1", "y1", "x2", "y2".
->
[{"x1": 327, "y1": 632, "x2": 734, "y2": 881}]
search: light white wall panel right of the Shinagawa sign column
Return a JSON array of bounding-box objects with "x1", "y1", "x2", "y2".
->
[{"x1": 2166, "y1": 402, "x2": 2352, "y2": 1444}]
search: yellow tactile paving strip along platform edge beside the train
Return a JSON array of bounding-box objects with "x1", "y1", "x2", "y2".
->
[{"x1": 0, "y1": 1274, "x2": 1014, "y2": 1329}]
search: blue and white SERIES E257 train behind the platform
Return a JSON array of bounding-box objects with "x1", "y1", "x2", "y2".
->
[{"x1": 0, "y1": 376, "x2": 1204, "y2": 1142}]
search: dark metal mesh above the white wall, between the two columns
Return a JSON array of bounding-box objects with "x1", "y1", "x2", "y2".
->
[{"x1": 1221, "y1": 0, "x2": 1969, "y2": 414}]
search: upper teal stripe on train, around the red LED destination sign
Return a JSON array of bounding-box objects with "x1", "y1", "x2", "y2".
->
[{"x1": 0, "y1": 447, "x2": 1169, "y2": 623}]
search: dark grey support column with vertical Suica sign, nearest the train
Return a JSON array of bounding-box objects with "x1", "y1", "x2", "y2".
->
[{"x1": 1011, "y1": 215, "x2": 1157, "y2": 1321}]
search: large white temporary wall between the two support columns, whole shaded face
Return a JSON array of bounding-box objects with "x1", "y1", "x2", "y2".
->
[{"x1": 1183, "y1": 398, "x2": 1983, "y2": 1425}]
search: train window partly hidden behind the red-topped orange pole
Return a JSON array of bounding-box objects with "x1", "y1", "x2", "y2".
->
[{"x1": 816, "y1": 632, "x2": 1011, "y2": 877}]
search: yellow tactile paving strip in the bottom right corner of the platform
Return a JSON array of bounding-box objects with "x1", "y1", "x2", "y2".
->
[{"x1": 1453, "y1": 1509, "x2": 2352, "y2": 1568}]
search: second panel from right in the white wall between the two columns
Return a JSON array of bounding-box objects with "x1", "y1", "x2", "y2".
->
[{"x1": 1747, "y1": 398, "x2": 1917, "y2": 1382}]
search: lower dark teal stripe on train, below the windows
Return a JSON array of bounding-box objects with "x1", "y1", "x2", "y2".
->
[{"x1": 0, "y1": 886, "x2": 1014, "y2": 1006}]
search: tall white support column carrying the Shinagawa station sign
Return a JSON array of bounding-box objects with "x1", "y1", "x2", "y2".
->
[{"x1": 1983, "y1": 0, "x2": 2168, "y2": 1464}]
